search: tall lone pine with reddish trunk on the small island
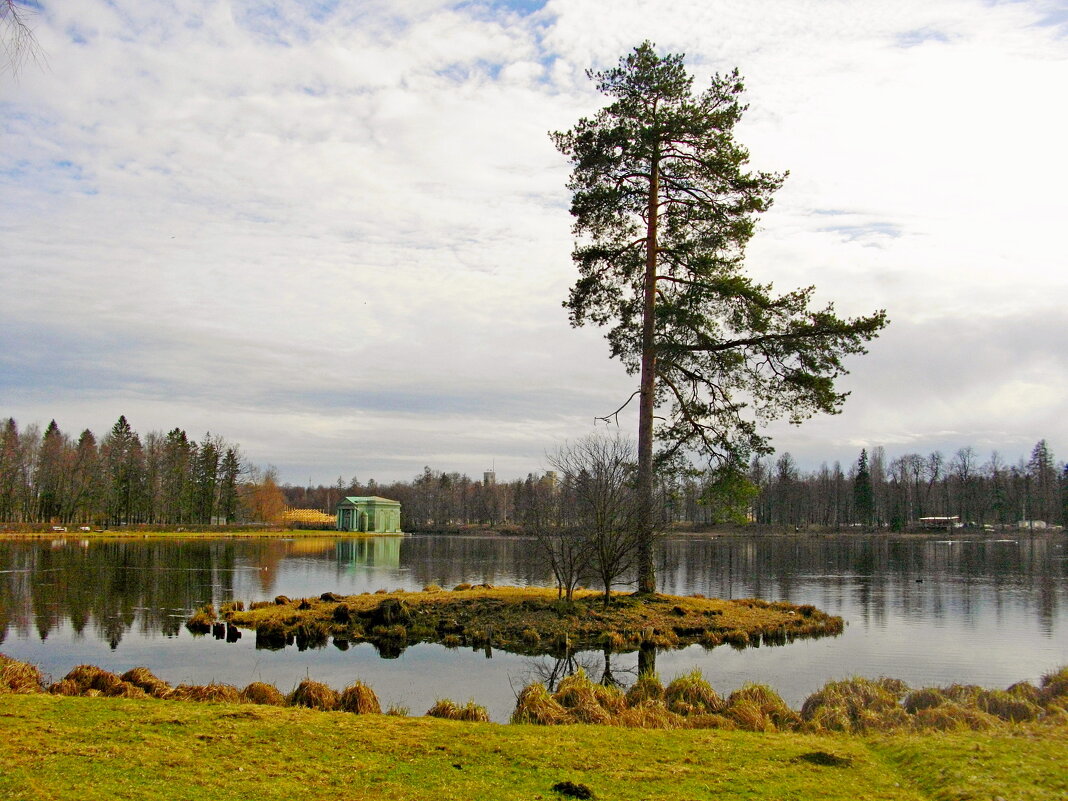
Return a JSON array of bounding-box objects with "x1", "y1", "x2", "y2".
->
[{"x1": 552, "y1": 42, "x2": 886, "y2": 593}]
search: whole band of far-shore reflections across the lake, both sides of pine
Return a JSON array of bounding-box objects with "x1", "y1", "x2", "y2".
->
[{"x1": 0, "y1": 535, "x2": 1068, "y2": 653}]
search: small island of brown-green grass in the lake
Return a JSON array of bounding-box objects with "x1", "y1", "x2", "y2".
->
[{"x1": 194, "y1": 584, "x2": 844, "y2": 655}]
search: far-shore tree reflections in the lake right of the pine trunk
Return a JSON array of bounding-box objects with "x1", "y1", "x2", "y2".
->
[{"x1": 658, "y1": 536, "x2": 1068, "y2": 632}]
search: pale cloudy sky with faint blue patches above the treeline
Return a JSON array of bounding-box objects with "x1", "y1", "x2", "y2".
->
[{"x1": 0, "y1": 0, "x2": 1068, "y2": 483}]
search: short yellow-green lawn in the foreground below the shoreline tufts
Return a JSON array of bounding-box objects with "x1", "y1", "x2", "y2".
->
[{"x1": 0, "y1": 694, "x2": 1068, "y2": 801}]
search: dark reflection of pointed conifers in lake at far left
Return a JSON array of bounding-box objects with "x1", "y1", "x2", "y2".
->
[{"x1": 0, "y1": 540, "x2": 242, "y2": 647}]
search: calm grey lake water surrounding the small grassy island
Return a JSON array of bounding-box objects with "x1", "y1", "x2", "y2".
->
[{"x1": 0, "y1": 534, "x2": 1068, "y2": 721}]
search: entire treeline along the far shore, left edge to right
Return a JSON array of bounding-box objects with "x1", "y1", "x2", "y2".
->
[{"x1": 0, "y1": 417, "x2": 1068, "y2": 531}]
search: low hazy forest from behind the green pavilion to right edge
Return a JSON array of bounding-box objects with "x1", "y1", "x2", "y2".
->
[{"x1": 282, "y1": 440, "x2": 1068, "y2": 531}]
